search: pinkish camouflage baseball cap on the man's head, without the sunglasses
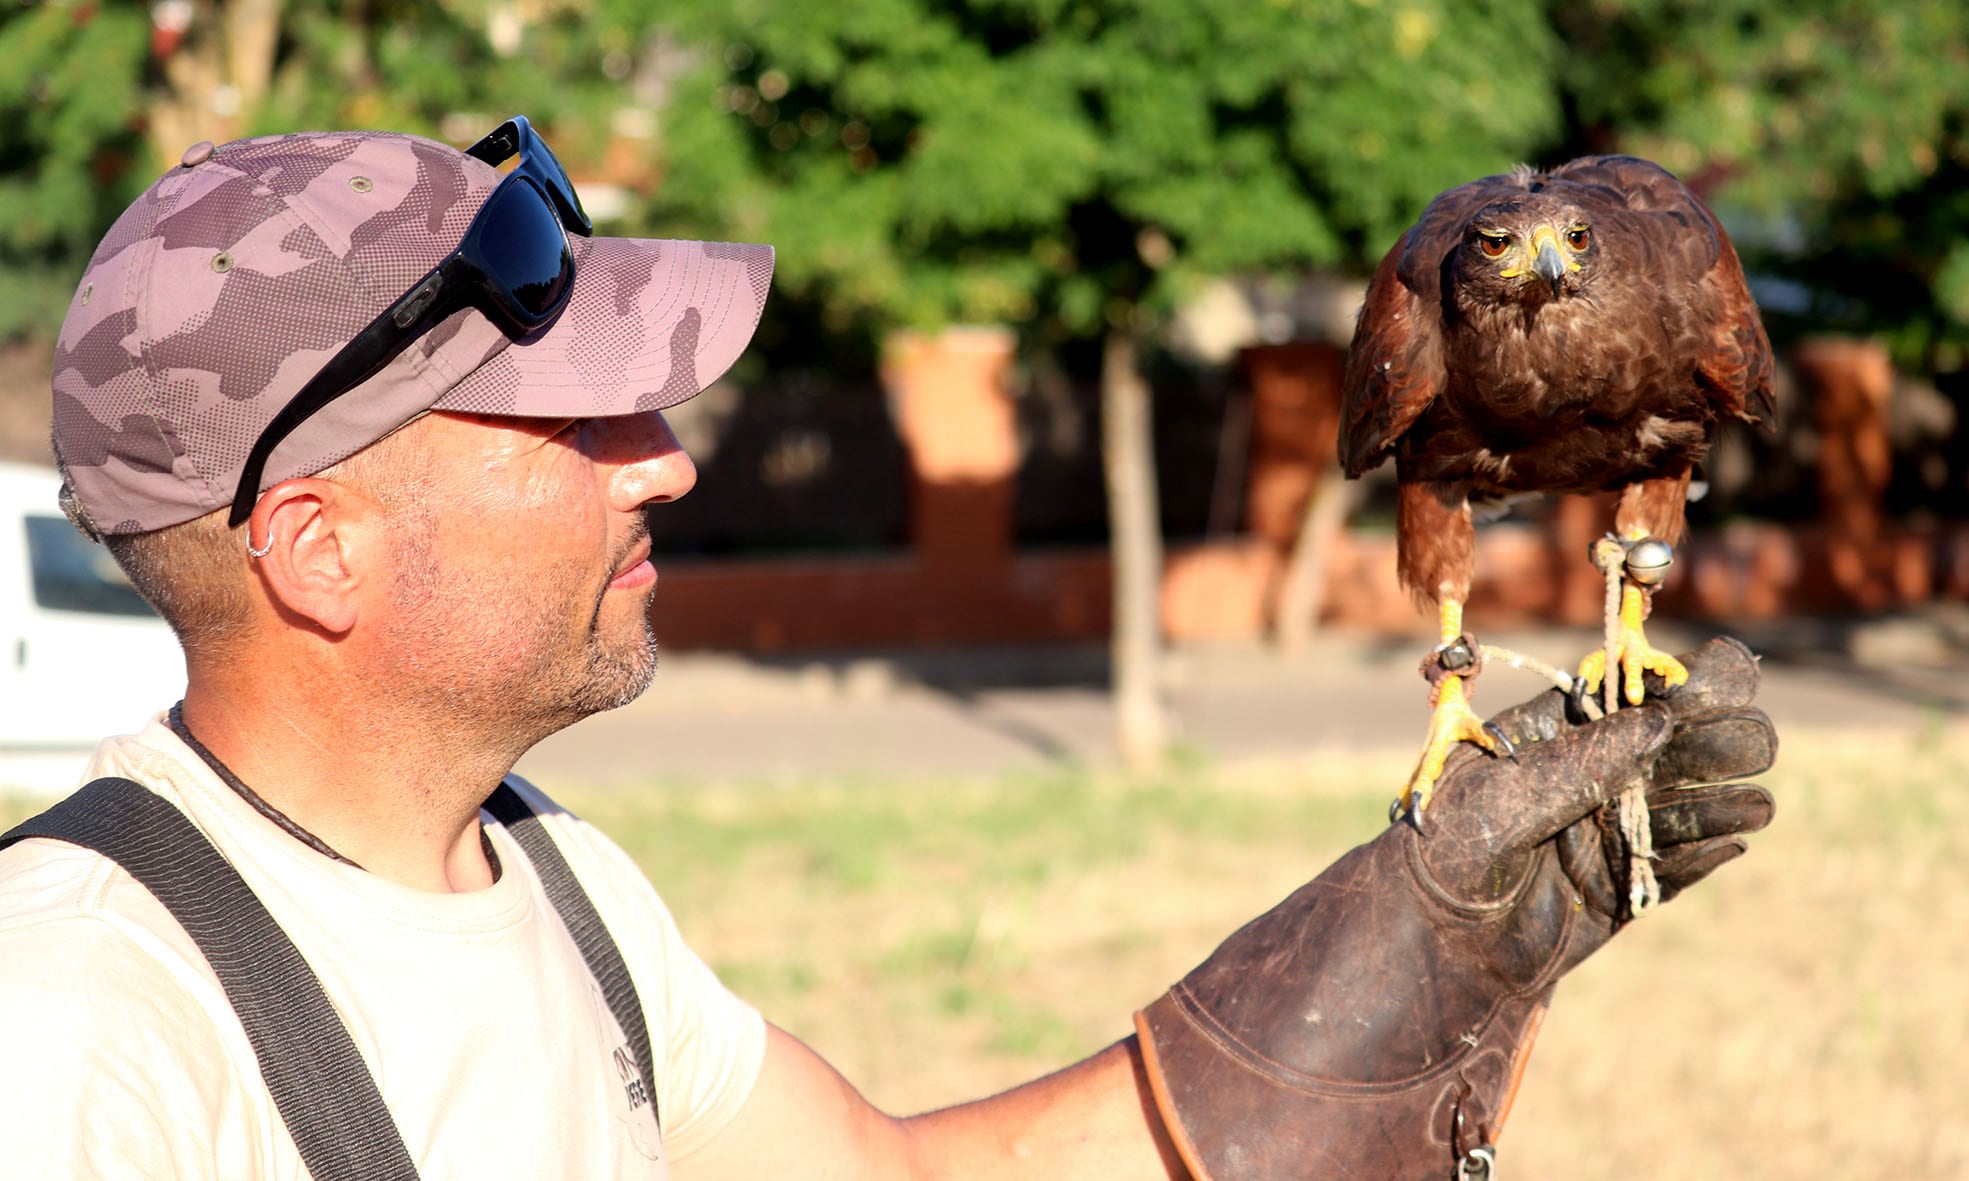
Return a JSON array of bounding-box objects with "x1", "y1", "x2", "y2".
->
[{"x1": 53, "y1": 132, "x2": 772, "y2": 533}]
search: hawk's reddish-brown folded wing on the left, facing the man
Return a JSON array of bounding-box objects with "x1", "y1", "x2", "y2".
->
[{"x1": 1339, "y1": 171, "x2": 1530, "y2": 476}]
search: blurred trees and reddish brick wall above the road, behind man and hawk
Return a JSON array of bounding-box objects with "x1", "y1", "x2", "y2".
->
[{"x1": 0, "y1": 0, "x2": 1969, "y2": 653}]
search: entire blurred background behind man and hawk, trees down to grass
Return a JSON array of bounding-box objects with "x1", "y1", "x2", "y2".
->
[{"x1": 0, "y1": 0, "x2": 1969, "y2": 1177}]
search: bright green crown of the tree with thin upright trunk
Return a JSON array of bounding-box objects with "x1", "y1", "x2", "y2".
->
[{"x1": 662, "y1": 0, "x2": 1559, "y2": 335}]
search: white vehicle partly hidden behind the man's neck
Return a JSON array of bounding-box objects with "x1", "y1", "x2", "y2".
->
[{"x1": 0, "y1": 463, "x2": 185, "y2": 751}]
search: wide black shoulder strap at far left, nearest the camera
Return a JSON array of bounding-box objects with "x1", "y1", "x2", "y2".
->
[{"x1": 0, "y1": 779, "x2": 417, "y2": 1181}]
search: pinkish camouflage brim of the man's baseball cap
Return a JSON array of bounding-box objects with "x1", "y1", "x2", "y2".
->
[{"x1": 431, "y1": 238, "x2": 772, "y2": 417}]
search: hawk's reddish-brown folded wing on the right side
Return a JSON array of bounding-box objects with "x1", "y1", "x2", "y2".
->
[{"x1": 1548, "y1": 155, "x2": 1776, "y2": 427}]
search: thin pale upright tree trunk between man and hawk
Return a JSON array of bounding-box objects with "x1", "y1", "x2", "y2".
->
[{"x1": 1101, "y1": 325, "x2": 1166, "y2": 768}]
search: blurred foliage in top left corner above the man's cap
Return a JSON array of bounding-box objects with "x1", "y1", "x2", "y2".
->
[{"x1": 0, "y1": 0, "x2": 628, "y2": 341}]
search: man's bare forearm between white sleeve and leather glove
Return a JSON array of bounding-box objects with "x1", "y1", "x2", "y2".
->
[{"x1": 671, "y1": 1026, "x2": 1189, "y2": 1181}]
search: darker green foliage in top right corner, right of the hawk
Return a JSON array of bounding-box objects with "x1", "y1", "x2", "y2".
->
[{"x1": 1554, "y1": 0, "x2": 1969, "y2": 368}]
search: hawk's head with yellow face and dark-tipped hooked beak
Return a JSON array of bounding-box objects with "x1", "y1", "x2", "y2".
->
[{"x1": 1451, "y1": 193, "x2": 1599, "y2": 303}]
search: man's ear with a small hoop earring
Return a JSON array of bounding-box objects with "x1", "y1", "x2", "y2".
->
[{"x1": 246, "y1": 478, "x2": 382, "y2": 636}]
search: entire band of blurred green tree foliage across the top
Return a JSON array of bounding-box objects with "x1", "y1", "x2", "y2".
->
[{"x1": 15, "y1": 0, "x2": 1969, "y2": 360}]
